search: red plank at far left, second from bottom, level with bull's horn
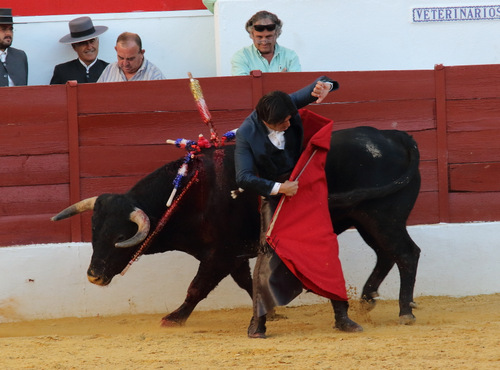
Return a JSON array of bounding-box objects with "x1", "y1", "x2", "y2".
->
[{"x1": 0, "y1": 184, "x2": 69, "y2": 217}]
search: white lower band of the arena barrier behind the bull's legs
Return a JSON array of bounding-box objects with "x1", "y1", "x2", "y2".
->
[{"x1": 0, "y1": 222, "x2": 500, "y2": 322}]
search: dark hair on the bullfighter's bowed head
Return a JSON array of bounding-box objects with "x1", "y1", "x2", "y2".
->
[{"x1": 255, "y1": 90, "x2": 297, "y2": 125}]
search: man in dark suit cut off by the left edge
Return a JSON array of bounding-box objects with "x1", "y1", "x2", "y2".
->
[{"x1": 0, "y1": 8, "x2": 28, "y2": 86}]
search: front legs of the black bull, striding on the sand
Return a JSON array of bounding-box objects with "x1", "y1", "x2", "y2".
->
[{"x1": 161, "y1": 255, "x2": 251, "y2": 326}]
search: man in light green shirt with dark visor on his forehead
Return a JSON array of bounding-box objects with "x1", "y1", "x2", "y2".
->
[{"x1": 231, "y1": 10, "x2": 301, "y2": 76}]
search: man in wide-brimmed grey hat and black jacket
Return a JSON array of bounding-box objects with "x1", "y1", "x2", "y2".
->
[{"x1": 50, "y1": 17, "x2": 109, "y2": 85}]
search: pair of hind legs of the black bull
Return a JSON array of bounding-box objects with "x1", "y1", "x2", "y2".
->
[{"x1": 358, "y1": 224, "x2": 420, "y2": 324}]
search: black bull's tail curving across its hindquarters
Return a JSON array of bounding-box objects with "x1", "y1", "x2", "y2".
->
[{"x1": 328, "y1": 131, "x2": 420, "y2": 208}]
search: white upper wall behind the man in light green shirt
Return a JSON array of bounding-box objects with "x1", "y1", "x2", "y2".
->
[{"x1": 215, "y1": 0, "x2": 500, "y2": 75}]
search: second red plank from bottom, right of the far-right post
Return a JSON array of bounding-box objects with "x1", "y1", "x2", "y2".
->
[{"x1": 450, "y1": 162, "x2": 500, "y2": 192}]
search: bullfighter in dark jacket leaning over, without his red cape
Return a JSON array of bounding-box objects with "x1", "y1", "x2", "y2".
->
[{"x1": 235, "y1": 76, "x2": 363, "y2": 338}]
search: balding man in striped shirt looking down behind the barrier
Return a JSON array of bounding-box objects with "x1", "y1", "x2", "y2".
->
[{"x1": 97, "y1": 32, "x2": 165, "y2": 82}]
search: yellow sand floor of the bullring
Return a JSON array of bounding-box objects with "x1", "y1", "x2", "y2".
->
[{"x1": 0, "y1": 294, "x2": 500, "y2": 369}]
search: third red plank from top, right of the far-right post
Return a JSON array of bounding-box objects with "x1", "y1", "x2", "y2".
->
[{"x1": 448, "y1": 131, "x2": 500, "y2": 163}]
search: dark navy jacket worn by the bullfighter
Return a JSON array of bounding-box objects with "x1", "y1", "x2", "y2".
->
[{"x1": 235, "y1": 76, "x2": 338, "y2": 196}]
